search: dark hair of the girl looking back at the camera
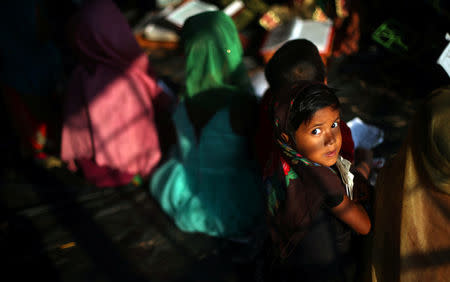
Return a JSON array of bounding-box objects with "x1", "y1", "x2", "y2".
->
[{"x1": 288, "y1": 81, "x2": 341, "y2": 132}]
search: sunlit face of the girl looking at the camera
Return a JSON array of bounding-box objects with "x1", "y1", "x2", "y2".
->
[{"x1": 295, "y1": 107, "x2": 342, "y2": 166}]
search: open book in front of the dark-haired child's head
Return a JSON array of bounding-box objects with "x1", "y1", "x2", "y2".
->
[{"x1": 260, "y1": 18, "x2": 334, "y2": 62}]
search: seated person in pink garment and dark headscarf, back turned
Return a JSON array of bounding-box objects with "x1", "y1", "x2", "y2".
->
[{"x1": 61, "y1": 0, "x2": 167, "y2": 177}]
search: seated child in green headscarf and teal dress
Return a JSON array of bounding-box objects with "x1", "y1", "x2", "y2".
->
[{"x1": 150, "y1": 12, "x2": 264, "y2": 239}]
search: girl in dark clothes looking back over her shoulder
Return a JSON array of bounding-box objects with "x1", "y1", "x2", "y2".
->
[{"x1": 264, "y1": 81, "x2": 371, "y2": 281}]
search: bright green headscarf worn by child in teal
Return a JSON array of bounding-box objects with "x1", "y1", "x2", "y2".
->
[{"x1": 181, "y1": 11, "x2": 251, "y2": 98}]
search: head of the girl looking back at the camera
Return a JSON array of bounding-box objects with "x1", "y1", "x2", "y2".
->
[{"x1": 287, "y1": 82, "x2": 342, "y2": 166}]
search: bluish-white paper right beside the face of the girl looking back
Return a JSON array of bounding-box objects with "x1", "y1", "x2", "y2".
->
[{"x1": 347, "y1": 117, "x2": 384, "y2": 149}]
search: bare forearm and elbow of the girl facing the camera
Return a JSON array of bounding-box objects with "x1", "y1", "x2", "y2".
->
[{"x1": 331, "y1": 195, "x2": 371, "y2": 235}]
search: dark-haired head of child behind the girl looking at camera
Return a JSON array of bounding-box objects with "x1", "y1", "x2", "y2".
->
[{"x1": 264, "y1": 39, "x2": 325, "y2": 90}]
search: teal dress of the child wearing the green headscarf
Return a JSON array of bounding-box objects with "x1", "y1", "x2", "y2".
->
[{"x1": 150, "y1": 102, "x2": 264, "y2": 238}]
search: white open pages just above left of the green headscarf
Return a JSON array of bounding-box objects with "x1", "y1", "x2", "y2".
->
[{"x1": 166, "y1": 0, "x2": 219, "y2": 27}]
